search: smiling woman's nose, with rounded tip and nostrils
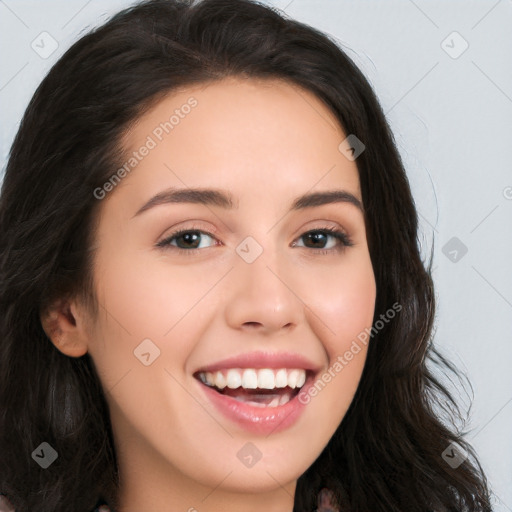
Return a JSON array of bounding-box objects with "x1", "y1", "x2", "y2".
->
[{"x1": 224, "y1": 245, "x2": 304, "y2": 335}]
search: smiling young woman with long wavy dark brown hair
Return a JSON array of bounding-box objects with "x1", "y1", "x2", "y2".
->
[{"x1": 0, "y1": 0, "x2": 490, "y2": 512}]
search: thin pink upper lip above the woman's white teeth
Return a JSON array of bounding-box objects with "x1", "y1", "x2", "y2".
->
[{"x1": 195, "y1": 351, "x2": 320, "y2": 373}]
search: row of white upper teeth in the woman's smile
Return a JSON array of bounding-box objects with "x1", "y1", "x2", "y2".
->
[{"x1": 199, "y1": 368, "x2": 306, "y2": 389}]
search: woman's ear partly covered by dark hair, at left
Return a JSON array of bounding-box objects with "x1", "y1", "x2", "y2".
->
[{"x1": 40, "y1": 299, "x2": 88, "y2": 357}]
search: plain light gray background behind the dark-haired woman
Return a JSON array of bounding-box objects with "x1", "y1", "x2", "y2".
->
[{"x1": 0, "y1": 0, "x2": 512, "y2": 512}]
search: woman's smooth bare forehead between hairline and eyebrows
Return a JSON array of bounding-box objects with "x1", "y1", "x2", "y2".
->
[{"x1": 103, "y1": 78, "x2": 360, "y2": 213}]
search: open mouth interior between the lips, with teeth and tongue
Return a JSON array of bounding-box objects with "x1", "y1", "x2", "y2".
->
[{"x1": 194, "y1": 368, "x2": 312, "y2": 408}]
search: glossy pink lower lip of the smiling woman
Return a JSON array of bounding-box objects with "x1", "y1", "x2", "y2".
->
[{"x1": 198, "y1": 377, "x2": 313, "y2": 435}]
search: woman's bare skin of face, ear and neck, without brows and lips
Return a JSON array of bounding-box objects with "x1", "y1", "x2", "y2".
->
[{"x1": 42, "y1": 78, "x2": 376, "y2": 512}]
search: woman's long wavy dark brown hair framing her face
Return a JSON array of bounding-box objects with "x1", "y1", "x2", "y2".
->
[{"x1": 0, "y1": 0, "x2": 491, "y2": 512}]
